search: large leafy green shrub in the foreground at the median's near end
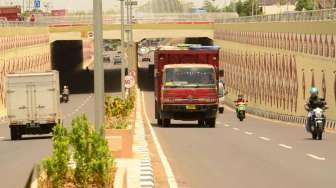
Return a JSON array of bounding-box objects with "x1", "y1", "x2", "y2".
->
[{"x1": 41, "y1": 115, "x2": 114, "y2": 187}]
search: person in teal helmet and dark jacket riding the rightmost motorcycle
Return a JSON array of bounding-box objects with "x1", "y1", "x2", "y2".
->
[{"x1": 305, "y1": 87, "x2": 328, "y2": 132}]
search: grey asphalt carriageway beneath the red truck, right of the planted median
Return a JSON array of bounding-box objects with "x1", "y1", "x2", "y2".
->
[{"x1": 140, "y1": 68, "x2": 336, "y2": 188}]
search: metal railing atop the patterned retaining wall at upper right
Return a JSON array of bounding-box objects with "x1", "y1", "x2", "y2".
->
[{"x1": 215, "y1": 8, "x2": 336, "y2": 23}]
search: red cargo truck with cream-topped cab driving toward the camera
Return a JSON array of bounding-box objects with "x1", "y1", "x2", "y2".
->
[{"x1": 154, "y1": 45, "x2": 223, "y2": 127}]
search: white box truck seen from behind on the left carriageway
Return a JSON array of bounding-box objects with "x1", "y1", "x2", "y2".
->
[{"x1": 5, "y1": 71, "x2": 60, "y2": 140}]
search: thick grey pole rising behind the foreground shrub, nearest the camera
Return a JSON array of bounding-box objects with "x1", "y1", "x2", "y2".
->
[{"x1": 93, "y1": 0, "x2": 104, "y2": 131}]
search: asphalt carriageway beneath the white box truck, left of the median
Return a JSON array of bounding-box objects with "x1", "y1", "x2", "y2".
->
[{"x1": 0, "y1": 94, "x2": 94, "y2": 188}]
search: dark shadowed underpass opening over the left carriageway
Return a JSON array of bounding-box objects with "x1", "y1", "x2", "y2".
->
[{"x1": 51, "y1": 40, "x2": 121, "y2": 94}]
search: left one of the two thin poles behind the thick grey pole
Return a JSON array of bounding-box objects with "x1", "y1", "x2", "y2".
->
[{"x1": 120, "y1": 0, "x2": 125, "y2": 99}]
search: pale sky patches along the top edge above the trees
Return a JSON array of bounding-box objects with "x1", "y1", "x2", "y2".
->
[{"x1": 0, "y1": 0, "x2": 230, "y2": 11}]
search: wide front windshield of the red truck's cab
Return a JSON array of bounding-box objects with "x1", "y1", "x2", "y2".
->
[{"x1": 164, "y1": 67, "x2": 215, "y2": 87}]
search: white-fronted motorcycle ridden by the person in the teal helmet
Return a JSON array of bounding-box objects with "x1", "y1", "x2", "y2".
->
[{"x1": 309, "y1": 108, "x2": 325, "y2": 140}]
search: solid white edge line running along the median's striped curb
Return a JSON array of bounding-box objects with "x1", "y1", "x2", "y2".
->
[{"x1": 138, "y1": 90, "x2": 178, "y2": 188}]
